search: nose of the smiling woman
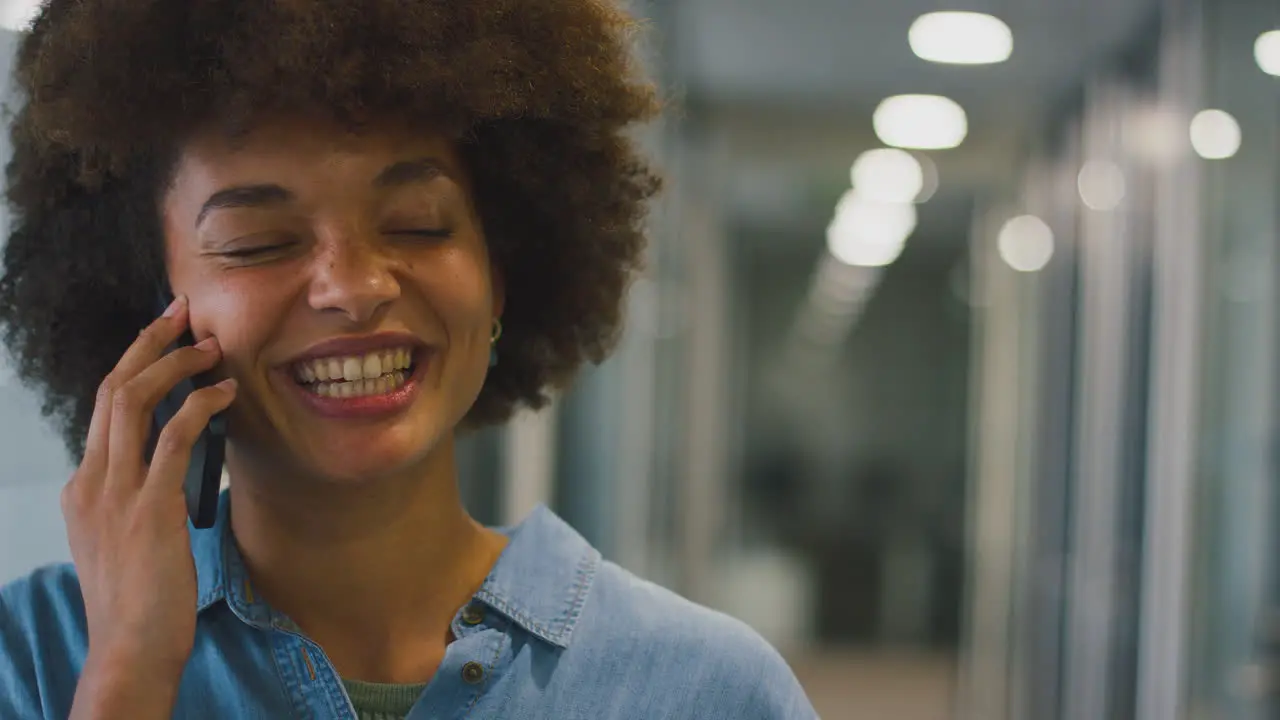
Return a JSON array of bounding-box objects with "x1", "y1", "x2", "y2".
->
[{"x1": 307, "y1": 233, "x2": 401, "y2": 323}]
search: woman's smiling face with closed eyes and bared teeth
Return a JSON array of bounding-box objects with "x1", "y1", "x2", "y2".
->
[{"x1": 161, "y1": 118, "x2": 502, "y2": 482}]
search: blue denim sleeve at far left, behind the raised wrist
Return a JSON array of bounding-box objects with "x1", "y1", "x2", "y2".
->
[{"x1": 0, "y1": 565, "x2": 87, "y2": 717}]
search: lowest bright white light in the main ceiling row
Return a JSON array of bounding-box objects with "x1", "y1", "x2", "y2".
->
[{"x1": 827, "y1": 190, "x2": 916, "y2": 268}]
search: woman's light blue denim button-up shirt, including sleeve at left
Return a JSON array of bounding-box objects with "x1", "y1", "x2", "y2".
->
[{"x1": 0, "y1": 496, "x2": 817, "y2": 720}]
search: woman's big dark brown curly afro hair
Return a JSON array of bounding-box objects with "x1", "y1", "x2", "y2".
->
[{"x1": 0, "y1": 0, "x2": 659, "y2": 459}]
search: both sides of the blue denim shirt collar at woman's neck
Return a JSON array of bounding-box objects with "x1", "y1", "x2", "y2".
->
[{"x1": 191, "y1": 492, "x2": 600, "y2": 648}]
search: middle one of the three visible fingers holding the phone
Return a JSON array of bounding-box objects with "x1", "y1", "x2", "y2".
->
[{"x1": 108, "y1": 337, "x2": 221, "y2": 487}]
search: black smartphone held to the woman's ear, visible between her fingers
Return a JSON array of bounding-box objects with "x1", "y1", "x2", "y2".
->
[{"x1": 147, "y1": 288, "x2": 227, "y2": 529}]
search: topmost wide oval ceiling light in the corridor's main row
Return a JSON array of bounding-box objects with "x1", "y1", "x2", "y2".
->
[{"x1": 906, "y1": 12, "x2": 1014, "y2": 65}]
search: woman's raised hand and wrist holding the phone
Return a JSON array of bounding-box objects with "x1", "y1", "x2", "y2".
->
[{"x1": 63, "y1": 294, "x2": 236, "y2": 717}]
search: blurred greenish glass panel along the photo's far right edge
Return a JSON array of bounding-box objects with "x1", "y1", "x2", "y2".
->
[{"x1": 1188, "y1": 0, "x2": 1280, "y2": 720}]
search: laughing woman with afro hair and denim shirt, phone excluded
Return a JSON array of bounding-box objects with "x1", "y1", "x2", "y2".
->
[{"x1": 0, "y1": 0, "x2": 814, "y2": 720}]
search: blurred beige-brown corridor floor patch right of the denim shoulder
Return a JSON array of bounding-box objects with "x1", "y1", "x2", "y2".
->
[{"x1": 790, "y1": 651, "x2": 956, "y2": 720}]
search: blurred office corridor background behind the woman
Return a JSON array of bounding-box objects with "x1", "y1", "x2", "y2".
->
[{"x1": 0, "y1": 0, "x2": 1280, "y2": 720}]
